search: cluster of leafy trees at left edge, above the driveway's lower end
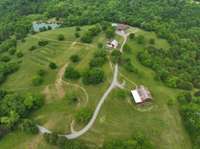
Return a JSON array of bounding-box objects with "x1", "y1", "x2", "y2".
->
[{"x1": 0, "y1": 93, "x2": 43, "y2": 129}]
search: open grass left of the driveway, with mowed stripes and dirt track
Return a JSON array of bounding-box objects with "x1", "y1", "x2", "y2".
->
[{"x1": 0, "y1": 26, "x2": 122, "y2": 149}]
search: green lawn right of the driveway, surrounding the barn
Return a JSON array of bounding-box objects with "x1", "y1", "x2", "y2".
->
[{"x1": 77, "y1": 30, "x2": 191, "y2": 149}]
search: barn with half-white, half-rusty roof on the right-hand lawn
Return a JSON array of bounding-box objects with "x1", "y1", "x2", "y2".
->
[{"x1": 131, "y1": 85, "x2": 152, "y2": 104}]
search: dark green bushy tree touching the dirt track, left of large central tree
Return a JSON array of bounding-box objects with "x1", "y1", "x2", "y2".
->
[{"x1": 64, "y1": 66, "x2": 81, "y2": 80}]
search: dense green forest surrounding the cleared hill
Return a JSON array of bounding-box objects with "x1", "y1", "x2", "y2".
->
[{"x1": 0, "y1": 0, "x2": 200, "y2": 146}]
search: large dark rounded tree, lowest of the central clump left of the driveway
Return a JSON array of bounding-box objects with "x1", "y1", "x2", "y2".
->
[{"x1": 83, "y1": 68, "x2": 105, "y2": 85}]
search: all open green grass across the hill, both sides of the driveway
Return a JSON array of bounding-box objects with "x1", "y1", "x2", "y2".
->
[{"x1": 0, "y1": 26, "x2": 191, "y2": 149}]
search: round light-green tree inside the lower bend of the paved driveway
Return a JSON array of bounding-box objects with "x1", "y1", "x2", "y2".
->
[{"x1": 75, "y1": 108, "x2": 93, "y2": 124}]
